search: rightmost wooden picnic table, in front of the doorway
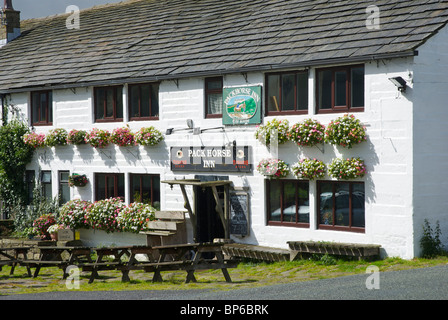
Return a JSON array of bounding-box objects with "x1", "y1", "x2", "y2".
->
[{"x1": 146, "y1": 243, "x2": 237, "y2": 283}]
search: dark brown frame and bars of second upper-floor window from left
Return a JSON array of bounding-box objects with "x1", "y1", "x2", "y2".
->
[{"x1": 93, "y1": 85, "x2": 124, "y2": 122}]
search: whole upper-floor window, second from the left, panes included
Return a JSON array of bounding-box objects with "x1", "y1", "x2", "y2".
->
[{"x1": 94, "y1": 86, "x2": 123, "y2": 122}]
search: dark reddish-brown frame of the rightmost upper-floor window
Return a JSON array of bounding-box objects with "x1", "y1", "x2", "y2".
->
[{"x1": 315, "y1": 64, "x2": 365, "y2": 114}]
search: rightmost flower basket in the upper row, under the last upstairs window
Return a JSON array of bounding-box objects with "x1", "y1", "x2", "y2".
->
[{"x1": 325, "y1": 114, "x2": 367, "y2": 149}]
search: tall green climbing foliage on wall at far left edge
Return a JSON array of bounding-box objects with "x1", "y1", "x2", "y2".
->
[{"x1": 0, "y1": 120, "x2": 34, "y2": 215}]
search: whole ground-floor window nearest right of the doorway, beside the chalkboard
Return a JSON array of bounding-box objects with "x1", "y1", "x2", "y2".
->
[{"x1": 266, "y1": 180, "x2": 310, "y2": 227}]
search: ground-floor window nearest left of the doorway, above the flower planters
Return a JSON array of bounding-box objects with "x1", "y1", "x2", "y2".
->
[{"x1": 131, "y1": 174, "x2": 160, "y2": 209}]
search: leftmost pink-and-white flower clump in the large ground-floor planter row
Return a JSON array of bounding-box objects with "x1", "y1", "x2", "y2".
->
[{"x1": 59, "y1": 199, "x2": 91, "y2": 229}]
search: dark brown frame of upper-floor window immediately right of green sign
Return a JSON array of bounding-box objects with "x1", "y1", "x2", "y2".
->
[{"x1": 265, "y1": 70, "x2": 309, "y2": 116}]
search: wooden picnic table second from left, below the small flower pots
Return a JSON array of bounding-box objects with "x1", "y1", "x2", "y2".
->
[{"x1": 23, "y1": 246, "x2": 92, "y2": 279}]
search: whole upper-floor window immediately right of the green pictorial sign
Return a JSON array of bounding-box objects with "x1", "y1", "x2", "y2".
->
[{"x1": 266, "y1": 71, "x2": 308, "y2": 115}]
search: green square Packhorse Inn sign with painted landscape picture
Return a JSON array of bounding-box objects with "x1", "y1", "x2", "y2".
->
[{"x1": 222, "y1": 86, "x2": 261, "y2": 125}]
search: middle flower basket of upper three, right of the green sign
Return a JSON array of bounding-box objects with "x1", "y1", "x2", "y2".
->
[{"x1": 287, "y1": 119, "x2": 325, "y2": 147}]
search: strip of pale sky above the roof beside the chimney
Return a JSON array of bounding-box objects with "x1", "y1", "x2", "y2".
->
[{"x1": 10, "y1": 0, "x2": 126, "y2": 20}]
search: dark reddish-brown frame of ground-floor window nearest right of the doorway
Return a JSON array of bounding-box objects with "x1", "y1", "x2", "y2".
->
[{"x1": 265, "y1": 179, "x2": 310, "y2": 228}]
